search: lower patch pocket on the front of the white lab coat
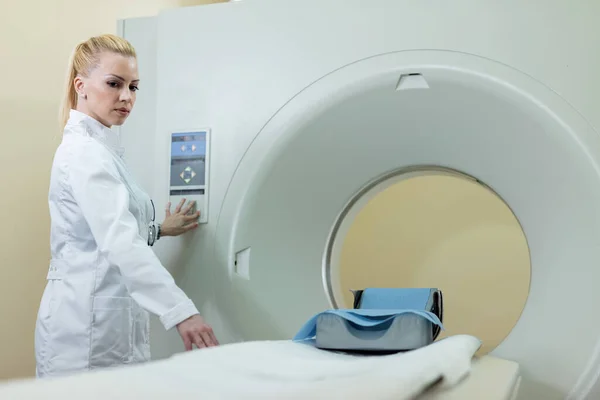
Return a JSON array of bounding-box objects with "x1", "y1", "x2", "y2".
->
[{"x1": 90, "y1": 296, "x2": 133, "y2": 369}]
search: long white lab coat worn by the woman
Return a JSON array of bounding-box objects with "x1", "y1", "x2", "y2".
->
[{"x1": 35, "y1": 111, "x2": 198, "y2": 377}]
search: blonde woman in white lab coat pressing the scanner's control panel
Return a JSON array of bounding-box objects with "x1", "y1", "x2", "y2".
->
[{"x1": 35, "y1": 35, "x2": 218, "y2": 377}]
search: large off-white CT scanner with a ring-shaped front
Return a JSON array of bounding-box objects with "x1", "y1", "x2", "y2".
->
[{"x1": 0, "y1": 0, "x2": 600, "y2": 399}]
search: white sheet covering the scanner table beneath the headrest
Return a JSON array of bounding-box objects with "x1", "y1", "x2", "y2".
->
[{"x1": 0, "y1": 335, "x2": 480, "y2": 400}]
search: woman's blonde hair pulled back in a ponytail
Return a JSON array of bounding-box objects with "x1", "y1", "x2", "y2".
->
[{"x1": 60, "y1": 34, "x2": 137, "y2": 129}]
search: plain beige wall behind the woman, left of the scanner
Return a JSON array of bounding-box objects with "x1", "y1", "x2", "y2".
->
[{"x1": 0, "y1": 0, "x2": 225, "y2": 379}]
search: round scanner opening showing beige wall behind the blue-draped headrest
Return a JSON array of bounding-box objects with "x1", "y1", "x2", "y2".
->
[{"x1": 326, "y1": 167, "x2": 531, "y2": 355}]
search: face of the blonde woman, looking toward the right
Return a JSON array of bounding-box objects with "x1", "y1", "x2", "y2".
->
[{"x1": 75, "y1": 52, "x2": 139, "y2": 127}]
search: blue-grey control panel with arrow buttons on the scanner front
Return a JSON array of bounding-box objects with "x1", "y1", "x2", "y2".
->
[{"x1": 169, "y1": 129, "x2": 210, "y2": 223}]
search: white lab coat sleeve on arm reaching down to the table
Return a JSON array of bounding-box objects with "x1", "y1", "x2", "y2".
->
[{"x1": 69, "y1": 141, "x2": 198, "y2": 330}]
